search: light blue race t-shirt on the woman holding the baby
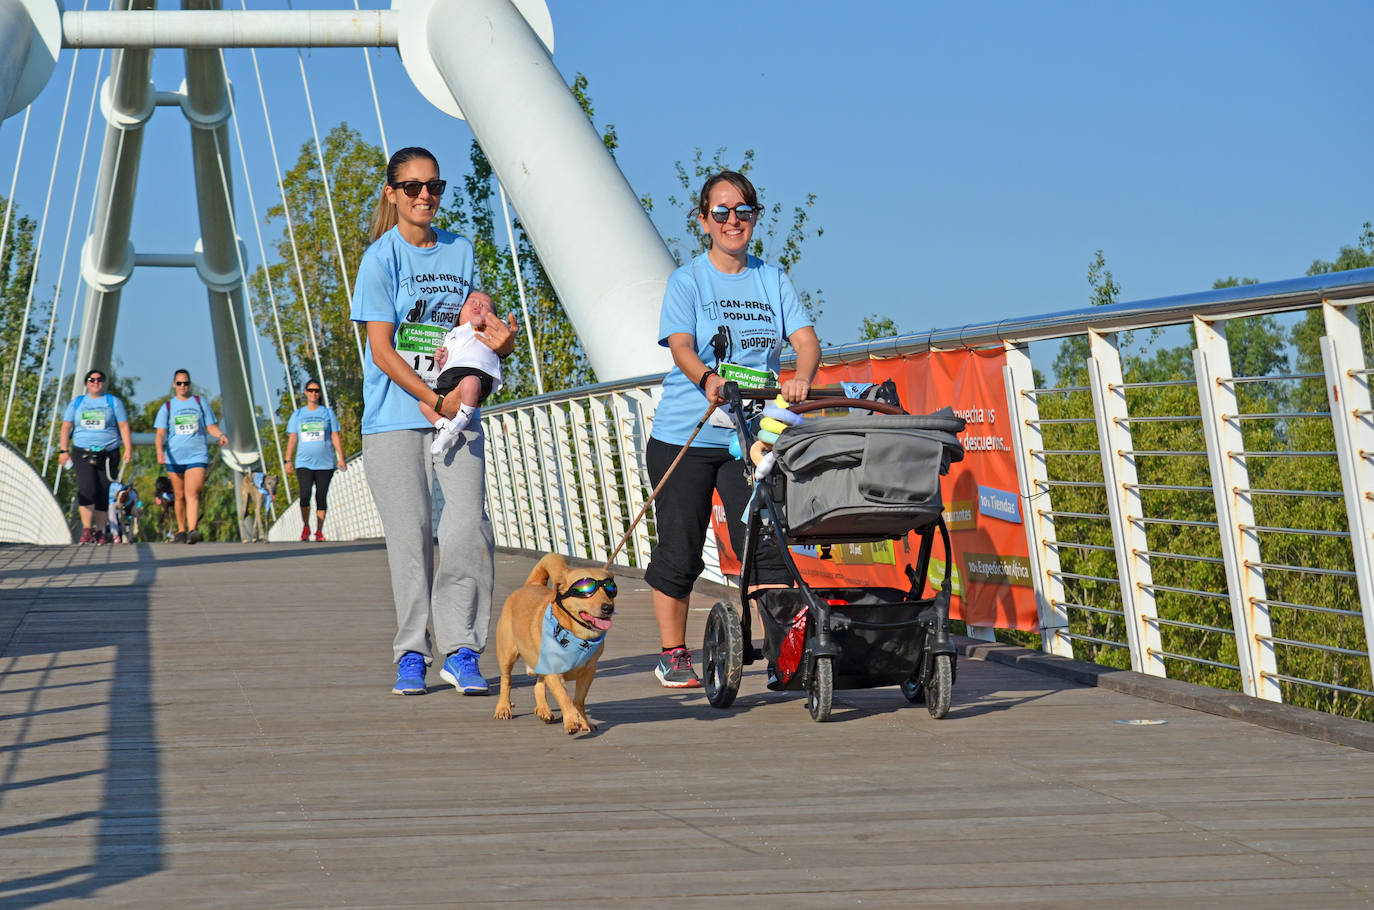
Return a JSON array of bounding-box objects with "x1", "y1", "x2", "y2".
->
[{"x1": 350, "y1": 228, "x2": 477, "y2": 436}]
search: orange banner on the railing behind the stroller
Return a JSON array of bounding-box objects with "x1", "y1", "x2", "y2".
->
[{"x1": 714, "y1": 351, "x2": 1040, "y2": 631}]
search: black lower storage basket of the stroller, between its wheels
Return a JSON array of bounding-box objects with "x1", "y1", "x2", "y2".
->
[{"x1": 757, "y1": 588, "x2": 936, "y2": 689}]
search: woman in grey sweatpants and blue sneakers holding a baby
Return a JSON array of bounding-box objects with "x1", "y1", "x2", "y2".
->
[{"x1": 352, "y1": 147, "x2": 515, "y2": 696}]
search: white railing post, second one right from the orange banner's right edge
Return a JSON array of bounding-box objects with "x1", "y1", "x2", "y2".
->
[{"x1": 1088, "y1": 329, "x2": 1167, "y2": 676}]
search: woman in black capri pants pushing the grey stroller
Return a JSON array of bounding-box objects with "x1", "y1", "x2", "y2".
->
[{"x1": 644, "y1": 170, "x2": 820, "y2": 689}]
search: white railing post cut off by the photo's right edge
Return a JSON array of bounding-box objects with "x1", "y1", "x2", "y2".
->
[{"x1": 1320, "y1": 298, "x2": 1374, "y2": 692}]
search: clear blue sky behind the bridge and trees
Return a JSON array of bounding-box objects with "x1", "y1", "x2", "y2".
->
[{"x1": 0, "y1": 0, "x2": 1374, "y2": 406}]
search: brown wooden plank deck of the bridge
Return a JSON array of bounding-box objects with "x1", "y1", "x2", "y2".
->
[{"x1": 0, "y1": 543, "x2": 1374, "y2": 910}]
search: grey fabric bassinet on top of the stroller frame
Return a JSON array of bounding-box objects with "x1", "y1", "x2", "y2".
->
[{"x1": 769, "y1": 408, "x2": 965, "y2": 543}]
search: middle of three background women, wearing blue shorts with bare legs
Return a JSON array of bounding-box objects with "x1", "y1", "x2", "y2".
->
[{"x1": 153, "y1": 370, "x2": 229, "y2": 543}]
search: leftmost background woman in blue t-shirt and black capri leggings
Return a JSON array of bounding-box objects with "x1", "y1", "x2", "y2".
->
[{"x1": 58, "y1": 370, "x2": 133, "y2": 543}]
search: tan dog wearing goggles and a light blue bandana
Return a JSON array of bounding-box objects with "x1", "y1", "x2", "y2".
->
[{"x1": 496, "y1": 553, "x2": 616, "y2": 735}]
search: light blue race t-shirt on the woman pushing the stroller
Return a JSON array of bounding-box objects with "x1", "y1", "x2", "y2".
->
[{"x1": 653, "y1": 253, "x2": 811, "y2": 448}]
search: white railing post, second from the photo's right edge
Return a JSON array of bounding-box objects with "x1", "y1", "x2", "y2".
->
[{"x1": 1193, "y1": 316, "x2": 1283, "y2": 701}]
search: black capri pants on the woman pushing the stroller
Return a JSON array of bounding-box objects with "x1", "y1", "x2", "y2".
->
[{"x1": 644, "y1": 437, "x2": 793, "y2": 598}]
